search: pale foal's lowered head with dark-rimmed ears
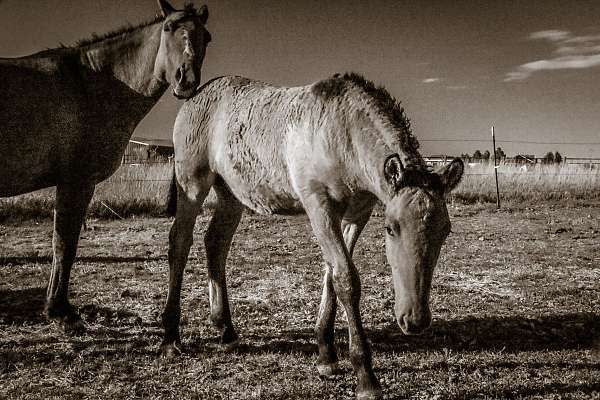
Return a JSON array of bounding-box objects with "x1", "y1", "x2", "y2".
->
[{"x1": 384, "y1": 154, "x2": 464, "y2": 335}]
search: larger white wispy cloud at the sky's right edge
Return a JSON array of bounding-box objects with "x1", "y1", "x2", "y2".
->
[{"x1": 504, "y1": 30, "x2": 600, "y2": 82}]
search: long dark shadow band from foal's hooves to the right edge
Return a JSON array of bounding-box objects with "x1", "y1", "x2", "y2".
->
[{"x1": 187, "y1": 313, "x2": 600, "y2": 356}]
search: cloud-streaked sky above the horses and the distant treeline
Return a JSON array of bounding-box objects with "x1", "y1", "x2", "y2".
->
[{"x1": 0, "y1": 0, "x2": 600, "y2": 158}]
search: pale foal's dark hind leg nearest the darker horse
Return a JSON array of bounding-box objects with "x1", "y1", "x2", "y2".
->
[{"x1": 160, "y1": 194, "x2": 204, "y2": 357}]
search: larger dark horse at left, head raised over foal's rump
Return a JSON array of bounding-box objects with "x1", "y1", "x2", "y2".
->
[{"x1": 0, "y1": 0, "x2": 210, "y2": 330}]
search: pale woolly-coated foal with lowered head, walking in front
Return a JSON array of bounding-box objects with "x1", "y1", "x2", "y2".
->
[{"x1": 162, "y1": 74, "x2": 463, "y2": 399}]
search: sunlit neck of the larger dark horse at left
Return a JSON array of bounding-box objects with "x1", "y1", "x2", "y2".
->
[{"x1": 81, "y1": 24, "x2": 168, "y2": 101}]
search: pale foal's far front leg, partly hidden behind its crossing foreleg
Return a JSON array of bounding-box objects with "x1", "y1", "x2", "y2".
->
[{"x1": 315, "y1": 197, "x2": 374, "y2": 376}]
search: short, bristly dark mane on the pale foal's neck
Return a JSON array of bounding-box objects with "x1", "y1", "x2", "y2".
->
[{"x1": 312, "y1": 72, "x2": 419, "y2": 157}]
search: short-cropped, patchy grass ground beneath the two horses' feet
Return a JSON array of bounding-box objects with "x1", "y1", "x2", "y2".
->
[{"x1": 0, "y1": 204, "x2": 600, "y2": 399}]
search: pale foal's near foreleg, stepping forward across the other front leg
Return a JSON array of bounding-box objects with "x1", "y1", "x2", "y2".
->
[{"x1": 303, "y1": 193, "x2": 381, "y2": 399}]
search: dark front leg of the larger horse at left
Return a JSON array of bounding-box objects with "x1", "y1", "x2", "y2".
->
[{"x1": 46, "y1": 184, "x2": 94, "y2": 332}]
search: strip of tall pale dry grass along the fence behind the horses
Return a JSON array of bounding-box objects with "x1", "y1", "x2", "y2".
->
[{"x1": 0, "y1": 159, "x2": 600, "y2": 222}]
